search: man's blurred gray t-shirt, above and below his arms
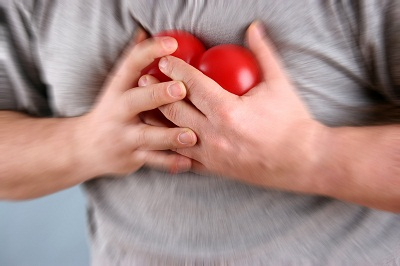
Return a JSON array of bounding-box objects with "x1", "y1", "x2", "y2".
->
[{"x1": 0, "y1": 0, "x2": 400, "y2": 265}]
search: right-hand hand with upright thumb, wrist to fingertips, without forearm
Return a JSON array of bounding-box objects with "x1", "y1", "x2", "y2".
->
[{"x1": 139, "y1": 21, "x2": 324, "y2": 191}]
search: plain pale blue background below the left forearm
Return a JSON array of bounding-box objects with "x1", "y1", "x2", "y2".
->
[{"x1": 0, "y1": 187, "x2": 90, "y2": 266}]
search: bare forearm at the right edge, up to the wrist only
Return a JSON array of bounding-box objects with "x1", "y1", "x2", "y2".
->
[{"x1": 313, "y1": 125, "x2": 400, "y2": 212}]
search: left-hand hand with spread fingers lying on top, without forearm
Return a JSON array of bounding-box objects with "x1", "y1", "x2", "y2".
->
[{"x1": 72, "y1": 34, "x2": 196, "y2": 178}]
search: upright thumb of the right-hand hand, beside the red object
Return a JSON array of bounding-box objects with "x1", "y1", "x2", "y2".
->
[{"x1": 247, "y1": 21, "x2": 287, "y2": 83}]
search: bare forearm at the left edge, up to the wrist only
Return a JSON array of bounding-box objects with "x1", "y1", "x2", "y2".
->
[{"x1": 0, "y1": 111, "x2": 89, "y2": 200}]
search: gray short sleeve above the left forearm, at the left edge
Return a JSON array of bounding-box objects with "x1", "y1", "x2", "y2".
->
[{"x1": 0, "y1": 0, "x2": 51, "y2": 116}]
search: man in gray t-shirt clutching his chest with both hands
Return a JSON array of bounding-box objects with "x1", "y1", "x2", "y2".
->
[{"x1": 0, "y1": 0, "x2": 400, "y2": 265}]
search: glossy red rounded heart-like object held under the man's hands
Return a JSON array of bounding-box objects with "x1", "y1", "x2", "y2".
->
[{"x1": 142, "y1": 30, "x2": 260, "y2": 96}]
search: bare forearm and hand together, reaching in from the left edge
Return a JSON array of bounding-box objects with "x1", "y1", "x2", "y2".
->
[{"x1": 0, "y1": 33, "x2": 197, "y2": 200}]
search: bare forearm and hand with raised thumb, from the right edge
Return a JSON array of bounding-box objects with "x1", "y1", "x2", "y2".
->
[{"x1": 139, "y1": 23, "x2": 400, "y2": 212}]
